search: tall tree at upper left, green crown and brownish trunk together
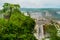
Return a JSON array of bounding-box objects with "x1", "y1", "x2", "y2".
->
[{"x1": 3, "y1": 3, "x2": 20, "y2": 21}]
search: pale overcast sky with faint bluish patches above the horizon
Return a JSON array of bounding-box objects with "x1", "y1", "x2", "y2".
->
[{"x1": 0, "y1": 0, "x2": 60, "y2": 8}]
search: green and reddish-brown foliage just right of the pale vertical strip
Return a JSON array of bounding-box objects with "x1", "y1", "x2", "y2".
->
[{"x1": 45, "y1": 23, "x2": 60, "y2": 40}]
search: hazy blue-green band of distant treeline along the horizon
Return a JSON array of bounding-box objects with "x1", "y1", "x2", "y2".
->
[{"x1": 21, "y1": 8, "x2": 60, "y2": 12}]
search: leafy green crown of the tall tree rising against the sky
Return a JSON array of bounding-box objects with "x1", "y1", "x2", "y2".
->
[{"x1": 3, "y1": 3, "x2": 20, "y2": 13}]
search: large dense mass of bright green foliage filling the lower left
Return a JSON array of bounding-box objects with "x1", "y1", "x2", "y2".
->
[{"x1": 0, "y1": 4, "x2": 36, "y2": 40}]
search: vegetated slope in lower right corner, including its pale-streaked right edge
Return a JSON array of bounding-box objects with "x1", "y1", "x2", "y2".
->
[{"x1": 44, "y1": 22, "x2": 60, "y2": 40}]
